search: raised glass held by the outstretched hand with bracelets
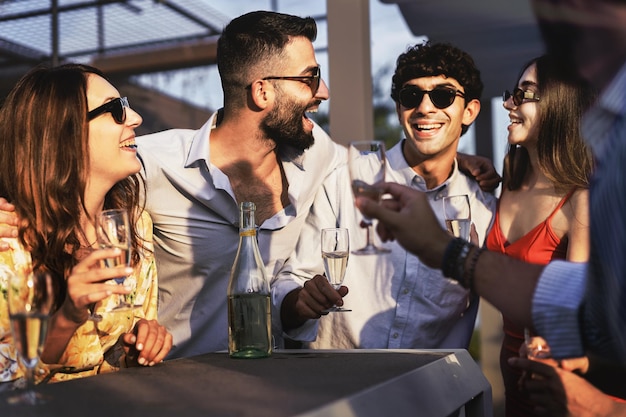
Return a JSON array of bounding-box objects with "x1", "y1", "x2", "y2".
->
[{"x1": 348, "y1": 141, "x2": 389, "y2": 255}]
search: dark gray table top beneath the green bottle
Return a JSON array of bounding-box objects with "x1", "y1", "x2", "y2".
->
[{"x1": 0, "y1": 350, "x2": 490, "y2": 417}]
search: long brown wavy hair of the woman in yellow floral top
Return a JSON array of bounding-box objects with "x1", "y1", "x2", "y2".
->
[{"x1": 0, "y1": 64, "x2": 144, "y2": 306}]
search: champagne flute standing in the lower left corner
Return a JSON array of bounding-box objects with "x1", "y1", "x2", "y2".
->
[{"x1": 7, "y1": 271, "x2": 54, "y2": 405}]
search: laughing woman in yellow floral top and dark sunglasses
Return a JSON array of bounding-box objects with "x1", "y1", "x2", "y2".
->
[{"x1": 0, "y1": 64, "x2": 172, "y2": 382}]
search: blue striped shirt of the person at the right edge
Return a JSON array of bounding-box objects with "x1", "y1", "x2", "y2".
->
[{"x1": 532, "y1": 65, "x2": 626, "y2": 364}]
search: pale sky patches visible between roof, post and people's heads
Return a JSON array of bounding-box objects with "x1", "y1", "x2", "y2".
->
[{"x1": 138, "y1": 0, "x2": 508, "y2": 168}]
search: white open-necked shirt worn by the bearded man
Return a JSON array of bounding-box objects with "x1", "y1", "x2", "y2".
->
[{"x1": 137, "y1": 114, "x2": 346, "y2": 359}]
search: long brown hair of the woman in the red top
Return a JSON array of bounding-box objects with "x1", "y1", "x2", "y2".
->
[{"x1": 504, "y1": 55, "x2": 596, "y2": 192}]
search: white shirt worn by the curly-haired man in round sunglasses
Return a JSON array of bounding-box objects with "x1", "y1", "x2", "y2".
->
[{"x1": 272, "y1": 143, "x2": 496, "y2": 349}]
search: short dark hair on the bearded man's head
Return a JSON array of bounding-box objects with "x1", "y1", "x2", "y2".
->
[{"x1": 217, "y1": 11, "x2": 317, "y2": 105}]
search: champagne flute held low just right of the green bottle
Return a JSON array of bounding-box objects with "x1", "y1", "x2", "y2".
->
[{"x1": 322, "y1": 227, "x2": 352, "y2": 312}]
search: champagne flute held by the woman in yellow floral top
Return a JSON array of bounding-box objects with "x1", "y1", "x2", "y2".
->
[{"x1": 96, "y1": 209, "x2": 133, "y2": 311}]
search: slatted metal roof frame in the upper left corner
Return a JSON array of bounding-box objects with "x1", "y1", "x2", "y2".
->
[{"x1": 0, "y1": 0, "x2": 230, "y2": 92}]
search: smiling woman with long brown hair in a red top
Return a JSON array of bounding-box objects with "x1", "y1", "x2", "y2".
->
[{"x1": 486, "y1": 56, "x2": 594, "y2": 417}]
